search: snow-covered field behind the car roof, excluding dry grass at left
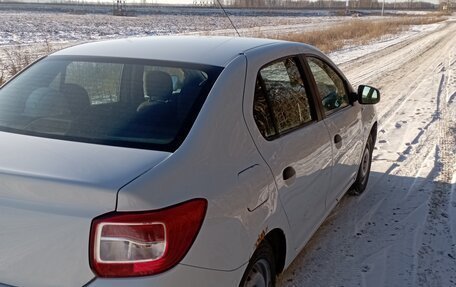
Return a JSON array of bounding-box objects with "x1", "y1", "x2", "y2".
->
[{"x1": 0, "y1": 5, "x2": 342, "y2": 45}]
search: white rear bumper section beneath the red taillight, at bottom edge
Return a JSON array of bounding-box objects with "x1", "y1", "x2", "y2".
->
[{"x1": 85, "y1": 264, "x2": 246, "y2": 287}]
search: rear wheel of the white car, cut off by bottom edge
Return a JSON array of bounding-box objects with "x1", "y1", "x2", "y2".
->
[{"x1": 239, "y1": 240, "x2": 276, "y2": 287}]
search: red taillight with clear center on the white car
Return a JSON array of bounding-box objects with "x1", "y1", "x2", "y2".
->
[{"x1": 90, "y1": 199, "x2": 207, "y2": 277}]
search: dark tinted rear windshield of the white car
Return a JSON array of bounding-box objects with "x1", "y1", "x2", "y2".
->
[{"x1": 0, "y1": 56, "x2": 222, "y2": 151}]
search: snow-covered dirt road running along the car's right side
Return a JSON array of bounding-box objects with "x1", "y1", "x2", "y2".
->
[{"x1": 278, "y1": 19, "x2": 456, "y2": 287}]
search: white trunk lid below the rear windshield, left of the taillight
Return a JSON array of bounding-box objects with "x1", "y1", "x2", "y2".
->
[{"x1": 0, "y1": 133, "x2": 169, "y2": 286}]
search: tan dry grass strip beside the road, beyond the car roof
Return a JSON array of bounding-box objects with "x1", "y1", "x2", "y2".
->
[{"x1": 277, "y1": 16, "x2": 446, "y2": 53}]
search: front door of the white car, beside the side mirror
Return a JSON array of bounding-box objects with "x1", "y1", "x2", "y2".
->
[{"x1": 306, "y1": 56, "x2": 363, "y2": 206}]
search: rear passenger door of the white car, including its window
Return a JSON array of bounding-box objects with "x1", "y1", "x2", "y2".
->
[{"x1": 244, "y1": 57, "x2": 332, "y2": 248}]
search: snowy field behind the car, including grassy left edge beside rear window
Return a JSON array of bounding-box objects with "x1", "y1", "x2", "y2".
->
[{"x1": 0, "y1": 4, "x2": 386, "y2": 80}]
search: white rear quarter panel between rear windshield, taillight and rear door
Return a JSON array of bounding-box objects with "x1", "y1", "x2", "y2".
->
[{"x1": 117, "y1": 56, "x2": 286, "y2": 274}]
